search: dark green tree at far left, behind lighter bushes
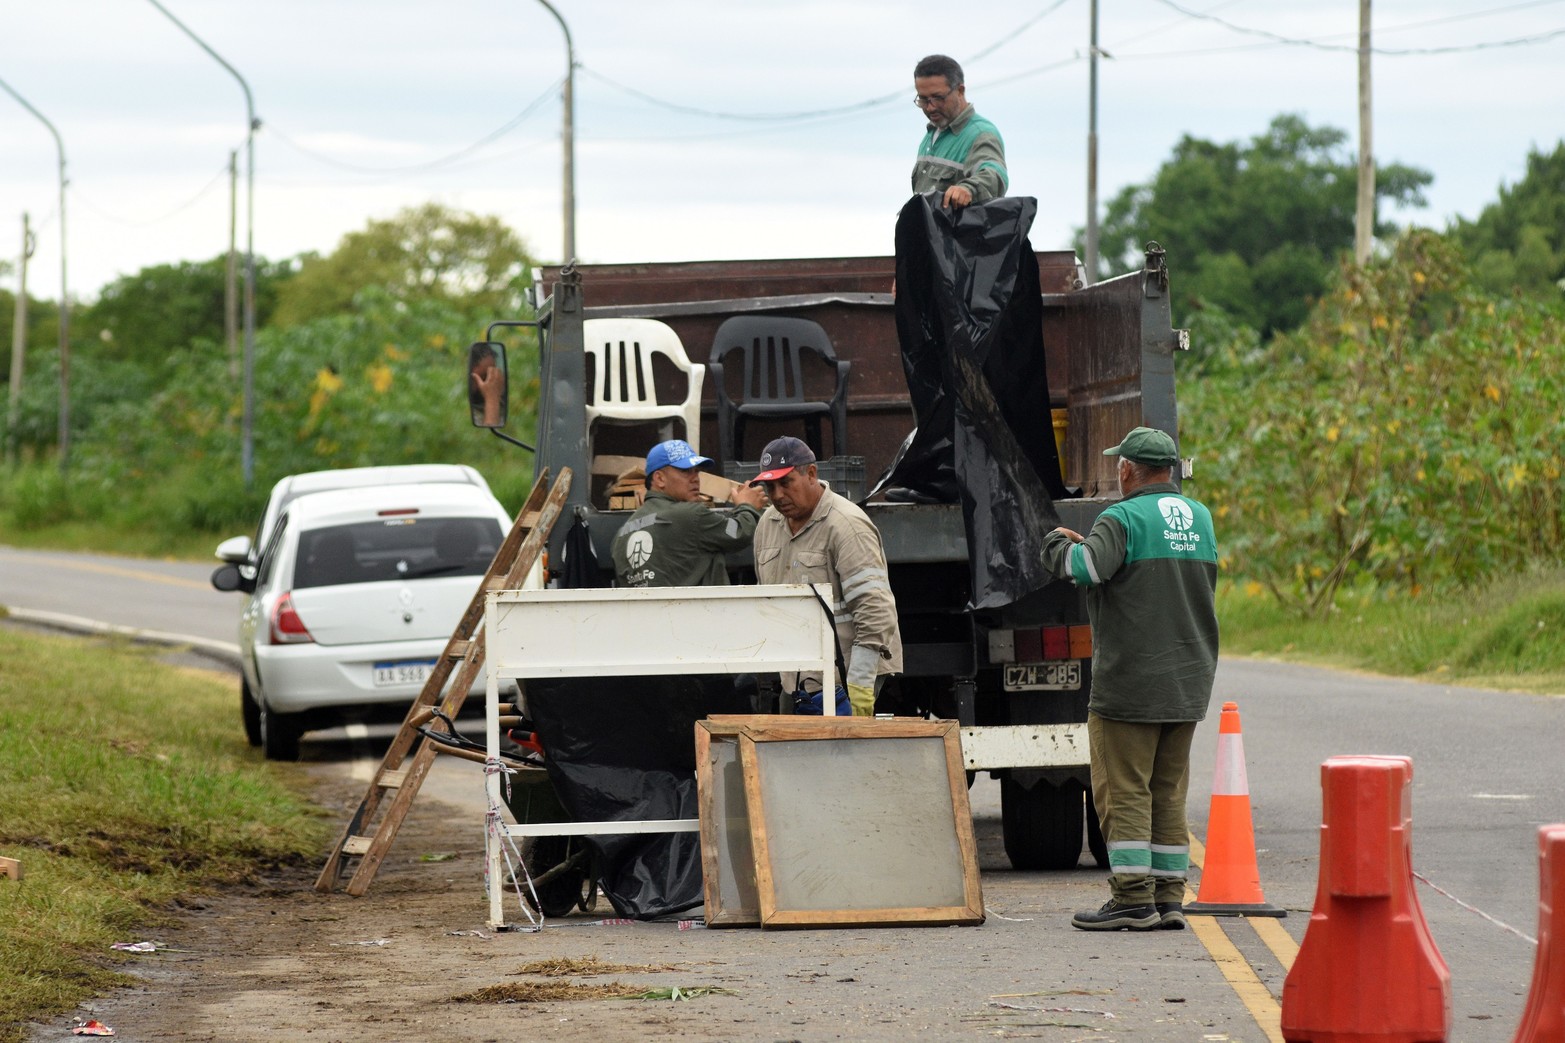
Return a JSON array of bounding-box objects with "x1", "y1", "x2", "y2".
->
[{"x1": 85, "y1": 254, "x2": 293, "y2": 360}]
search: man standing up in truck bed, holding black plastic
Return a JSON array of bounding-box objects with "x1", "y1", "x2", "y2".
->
[{"x1": 912, "y1": 55, "x2": 1009, "y2": 210}]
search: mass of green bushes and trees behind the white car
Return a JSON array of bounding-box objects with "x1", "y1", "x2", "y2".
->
[{"x1": 0, "y1": 207, "x2": 537, "y2": 544}]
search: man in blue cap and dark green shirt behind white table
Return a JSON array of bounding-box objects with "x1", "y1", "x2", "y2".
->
[{"x1": 613, "y1": 438, "x2": 765, "y2": 587}]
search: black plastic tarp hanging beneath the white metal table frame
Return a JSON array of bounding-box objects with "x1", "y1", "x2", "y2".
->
[{"x1": 527, "y1": 675, "x2": 754, "y2": 919}]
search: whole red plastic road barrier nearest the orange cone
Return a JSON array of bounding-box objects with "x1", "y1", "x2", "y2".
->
[{"x1": 1282, "y1": 756, "x2": 1451, "y2": 1043}]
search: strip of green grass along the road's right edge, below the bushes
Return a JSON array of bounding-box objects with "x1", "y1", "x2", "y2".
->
[{"x1": 1218, "y1": 570, "x2": 1565, "y2": 694}]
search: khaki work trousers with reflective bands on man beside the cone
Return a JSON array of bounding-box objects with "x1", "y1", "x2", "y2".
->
[{"x1": 1086, "y1": 713, "x2": 1196, "y2": 905}]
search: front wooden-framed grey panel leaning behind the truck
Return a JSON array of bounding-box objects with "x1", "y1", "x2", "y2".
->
[{"x1": 732, "y1": 717, "x2": 984, "y2": 927}]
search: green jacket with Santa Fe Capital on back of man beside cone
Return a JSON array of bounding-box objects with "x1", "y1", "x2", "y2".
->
[{"x1": 1042, "y1": 482, "x2": 1218, "y2": 722}]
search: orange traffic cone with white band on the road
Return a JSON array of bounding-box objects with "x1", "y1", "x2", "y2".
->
[{"x1": 1185, "y1": 703, "x2": 1288, "y2": 916}]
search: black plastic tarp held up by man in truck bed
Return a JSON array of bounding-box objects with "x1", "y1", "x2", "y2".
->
[{"x1": 881, "y1": 196, "x2": 1066, "y2": 608}]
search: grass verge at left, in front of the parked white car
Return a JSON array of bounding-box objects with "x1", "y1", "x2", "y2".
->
[{"x1": 0, "y1": 626, "x2": 330, "y2": 1043}]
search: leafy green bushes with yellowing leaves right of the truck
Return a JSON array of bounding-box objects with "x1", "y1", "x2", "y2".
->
[{"x1": 1180, "y1": 232, "x2": 1565, "y2": 609}]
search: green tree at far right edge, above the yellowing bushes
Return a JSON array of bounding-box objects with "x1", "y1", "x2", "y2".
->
[{"x1": 1451, "y1": 141, "x2": 1565, "y2": 299}]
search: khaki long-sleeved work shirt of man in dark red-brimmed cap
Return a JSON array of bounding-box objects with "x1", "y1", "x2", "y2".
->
[{"x1": 754, "y1": 482, "x2": 901, "y2": 692}]
